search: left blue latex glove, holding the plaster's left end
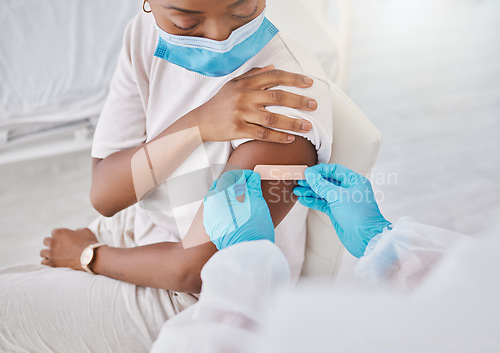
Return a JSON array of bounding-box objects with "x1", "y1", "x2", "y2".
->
[{"x1": 203, "y1": 170, "x2": 274, "y2": 250}]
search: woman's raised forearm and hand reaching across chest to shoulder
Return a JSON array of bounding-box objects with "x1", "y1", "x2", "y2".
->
[{"x1": 90, "y1": 65, "x2": 317, "y2": 217}]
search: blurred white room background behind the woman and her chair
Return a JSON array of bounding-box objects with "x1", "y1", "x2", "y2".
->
[{"x1": 0, "y1": 0, "x2": 500, "y2": 268}]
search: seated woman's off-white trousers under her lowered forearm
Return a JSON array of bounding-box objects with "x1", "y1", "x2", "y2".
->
[{"x1": 0, "y1": 207, "x2": 198, "y2": 353}]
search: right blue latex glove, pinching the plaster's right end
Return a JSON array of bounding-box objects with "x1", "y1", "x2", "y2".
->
[{"x1": 293, "y1": 164, "x2": 391, "y2": 258}]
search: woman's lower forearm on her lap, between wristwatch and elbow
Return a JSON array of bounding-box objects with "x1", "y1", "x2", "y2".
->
[{"x1": 90, "y1": 242, "x2": 217, "y2": 293}]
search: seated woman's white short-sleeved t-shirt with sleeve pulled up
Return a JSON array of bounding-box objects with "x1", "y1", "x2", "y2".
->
[{"x1": 92, "y1": 12, "x2": 332, "y2": 280}]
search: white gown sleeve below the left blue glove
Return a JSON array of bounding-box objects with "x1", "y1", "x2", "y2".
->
[{"x1": 151, "y1": 240, "x2": 290, "y2": 353}]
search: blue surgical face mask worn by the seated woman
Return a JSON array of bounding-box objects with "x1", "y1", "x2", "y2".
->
[{"x1": 155, "y1": 11, "x2": 278, "y2": 77}]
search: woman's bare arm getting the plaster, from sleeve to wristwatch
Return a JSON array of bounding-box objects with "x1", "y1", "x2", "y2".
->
[{"x1": 91, "y1": 137, "x2": 317, "y2": 293}]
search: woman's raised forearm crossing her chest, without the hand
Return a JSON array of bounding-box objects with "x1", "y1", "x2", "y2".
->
[{"x1": 90, "y1": 113, "x2": 203, "y2": 217}]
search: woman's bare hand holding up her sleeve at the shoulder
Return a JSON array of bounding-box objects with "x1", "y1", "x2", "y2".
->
[{"x1": 190, "y1": 65, "x2": 318, "y2": 143}]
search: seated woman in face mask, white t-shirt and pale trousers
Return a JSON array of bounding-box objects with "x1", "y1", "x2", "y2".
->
[{"x1": 0, "y1": 0, "x2": 332, "y2": 353}]
